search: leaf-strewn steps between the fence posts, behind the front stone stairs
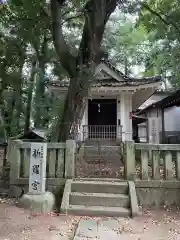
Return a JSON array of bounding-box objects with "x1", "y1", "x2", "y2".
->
[{"x1": 76, "y1": 139, "x2": 124, "y2": 178}]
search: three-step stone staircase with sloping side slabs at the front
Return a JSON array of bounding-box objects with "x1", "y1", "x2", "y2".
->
[{"x1": 61, "y1": 179, "x2": 138, "y2": 217}]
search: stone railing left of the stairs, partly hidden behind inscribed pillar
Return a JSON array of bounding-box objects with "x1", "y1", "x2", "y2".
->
[{"x1": 8, "y1": 140, "x2": 76, "y2": 188}]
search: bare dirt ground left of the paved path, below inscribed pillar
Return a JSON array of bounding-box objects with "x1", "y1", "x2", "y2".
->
[{"x1": 0, "y1": 203, "x2": 79, "y2": 240}]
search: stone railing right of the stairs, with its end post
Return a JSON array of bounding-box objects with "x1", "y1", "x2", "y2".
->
[{"x1": 125, "y1": 142, "x2": 180, "y2": 180}]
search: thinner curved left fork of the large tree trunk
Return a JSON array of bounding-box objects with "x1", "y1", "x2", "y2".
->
[{"x1": 51, "y1": 0, "x2": 76, "y2": 77}]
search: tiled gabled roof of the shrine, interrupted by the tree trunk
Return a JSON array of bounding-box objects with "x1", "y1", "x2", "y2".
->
[{"x1": 47, "y1": 59, "x2": 162, "y2": 88}]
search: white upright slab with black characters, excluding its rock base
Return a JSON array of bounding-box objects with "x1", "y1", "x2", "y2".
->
[{"x1": 29, "y1": 143, "x2": 47, "y2": 194}]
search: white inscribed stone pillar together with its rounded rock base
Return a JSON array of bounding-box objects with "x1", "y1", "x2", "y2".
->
[{"x1": 19, "y1": 143, "x2": 55, "y2": 213}]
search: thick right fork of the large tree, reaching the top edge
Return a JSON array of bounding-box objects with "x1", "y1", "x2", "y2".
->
[{"x1": 78, "y1": 0, "x2": 118, "y2": 64}]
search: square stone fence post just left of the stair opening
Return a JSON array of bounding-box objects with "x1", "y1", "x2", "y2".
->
[{"x1": 65, "y1": 140, "x2": 76, "y2": 178}]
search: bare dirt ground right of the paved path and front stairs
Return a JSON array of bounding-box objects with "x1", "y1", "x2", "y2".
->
[{"x1": 118, "y1": 205, "x2": 180, "y2": 240}]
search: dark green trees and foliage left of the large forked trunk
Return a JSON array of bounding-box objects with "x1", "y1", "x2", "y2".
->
[{"x1": 0, "y1": 0, "x2": 63, "y2": 140}]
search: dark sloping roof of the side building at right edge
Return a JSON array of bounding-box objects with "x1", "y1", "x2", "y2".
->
[{"x1": 137, "y1": 90, "x2": 180, "y2": 115}]
